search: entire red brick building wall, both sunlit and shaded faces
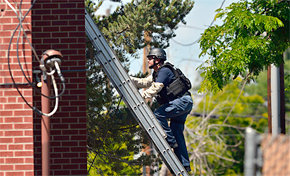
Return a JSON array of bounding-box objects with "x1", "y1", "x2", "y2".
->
[{"x1": 0, "y1": 0, "x2": 87, "y2": 176}]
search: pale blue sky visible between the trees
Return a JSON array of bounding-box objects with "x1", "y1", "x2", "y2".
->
[{"x1": 98, "y1": 0, "x2": 238, "y2": 85}]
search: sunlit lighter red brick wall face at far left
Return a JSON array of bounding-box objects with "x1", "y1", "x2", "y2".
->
[{"x1": 0, "y1": 0, "x2": 34, "y2": 176}]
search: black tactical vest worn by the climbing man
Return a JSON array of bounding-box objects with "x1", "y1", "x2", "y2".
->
[{"x1": 153, "y1": 62, "x2": 191, "y2": 104}]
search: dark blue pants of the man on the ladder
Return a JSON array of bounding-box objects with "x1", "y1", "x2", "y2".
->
[{"x1": 154, "y1": 95, "x2": 192, "y2": 166}]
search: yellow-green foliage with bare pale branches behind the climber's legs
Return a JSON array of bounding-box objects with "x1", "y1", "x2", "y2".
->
[{"x1": 185, "y1": 81, "x2": 267, "y2": 175}]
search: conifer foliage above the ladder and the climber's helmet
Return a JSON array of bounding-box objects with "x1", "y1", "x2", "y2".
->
[{"x1": 92, "y1": 0, "x2": 194, "y2": 56}]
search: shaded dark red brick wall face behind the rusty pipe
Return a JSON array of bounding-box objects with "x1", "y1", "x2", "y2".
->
[{"x1": 32, "y1": 0, "x2": 87, "y2": 175}]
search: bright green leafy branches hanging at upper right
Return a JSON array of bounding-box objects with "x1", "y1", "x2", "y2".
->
[{"x1": 200, "y1": 0, "x2": 290, "y2": 91}]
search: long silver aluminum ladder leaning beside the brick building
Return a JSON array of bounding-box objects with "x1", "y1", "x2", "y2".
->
[{"x1": 85, "y1": 11, "x2": 188, "y2": 176}]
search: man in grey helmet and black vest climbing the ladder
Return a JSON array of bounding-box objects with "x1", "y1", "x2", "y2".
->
[{"x1": 131, "y1": 48, "x2": 192, "y2": 172}]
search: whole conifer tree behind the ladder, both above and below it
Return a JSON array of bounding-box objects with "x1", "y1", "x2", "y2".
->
[{"x1": 86, "y1": 0, "x2": 193, "y2": 175}]
